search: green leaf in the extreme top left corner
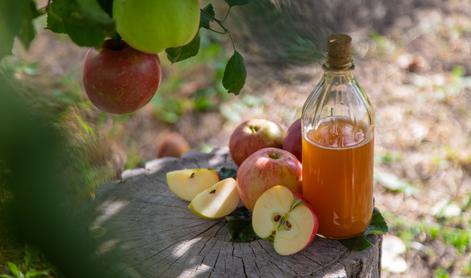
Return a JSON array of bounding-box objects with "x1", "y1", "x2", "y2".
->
[{"x1": 0, "y1": 0, "x2": 37, "y2": 58}]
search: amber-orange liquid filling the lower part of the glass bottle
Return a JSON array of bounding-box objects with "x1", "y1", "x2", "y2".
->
[{"x1": 302, "y1": 117, "x2": 374, "y2": 239}]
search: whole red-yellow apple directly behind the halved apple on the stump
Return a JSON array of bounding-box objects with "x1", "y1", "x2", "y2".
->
[{"x1": 237, "y1": 148, "x2": 302, "y2": 210}]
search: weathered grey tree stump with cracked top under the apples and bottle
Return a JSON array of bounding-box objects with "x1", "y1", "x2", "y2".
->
[{"x1": 94, "y1": 149, "x2": 382, "y2": 278}]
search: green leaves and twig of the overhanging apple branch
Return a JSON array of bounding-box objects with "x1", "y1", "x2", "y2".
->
[{"x1": 0, "y1": 0, "x2": 253, "y2": 94}]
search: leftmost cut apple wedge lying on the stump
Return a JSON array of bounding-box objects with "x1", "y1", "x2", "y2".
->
[{"x1": 167, "y1": 168, "x2": 219, "y2": 201}]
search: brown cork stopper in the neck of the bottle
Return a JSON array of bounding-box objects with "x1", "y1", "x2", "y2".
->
[{"x1": 324, "y1": 34, "x2": 353, "y2": 70}]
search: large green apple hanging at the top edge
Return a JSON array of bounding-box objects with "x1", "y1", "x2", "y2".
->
[{"x1": 113, "y1": 0, "x2": 200, "y2": 54}]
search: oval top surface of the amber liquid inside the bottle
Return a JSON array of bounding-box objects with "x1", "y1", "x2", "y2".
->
[{"x1": 308, "y1": 117, "x2": 367, "y2": 148}]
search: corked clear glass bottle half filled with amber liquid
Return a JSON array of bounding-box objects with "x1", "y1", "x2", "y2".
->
[{"x1": 302, "y1": 34, "x2": 374, "y2": 239}]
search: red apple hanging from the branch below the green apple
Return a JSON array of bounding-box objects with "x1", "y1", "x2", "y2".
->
[{"x1": 83, "y1": 40, "x2": 161, "y2": 114}]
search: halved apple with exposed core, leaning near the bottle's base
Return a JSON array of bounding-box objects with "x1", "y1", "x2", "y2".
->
[{"x1": 252, "y1": 185, "x2": 319, "y2": 255}]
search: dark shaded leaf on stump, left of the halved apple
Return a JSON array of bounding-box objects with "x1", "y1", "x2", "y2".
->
[{"x1": 226, "y1": 207, "x2": 258, "y2": 242}]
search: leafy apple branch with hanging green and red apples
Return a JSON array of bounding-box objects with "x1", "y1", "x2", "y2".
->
[{"x1": 0, "y1": 0, "x2": 249, "y2": 114}]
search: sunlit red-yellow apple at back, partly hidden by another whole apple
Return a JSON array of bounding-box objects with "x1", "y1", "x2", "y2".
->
[{"x1": 229, "y1": 119, "x2": 285, "y2": 165}]
